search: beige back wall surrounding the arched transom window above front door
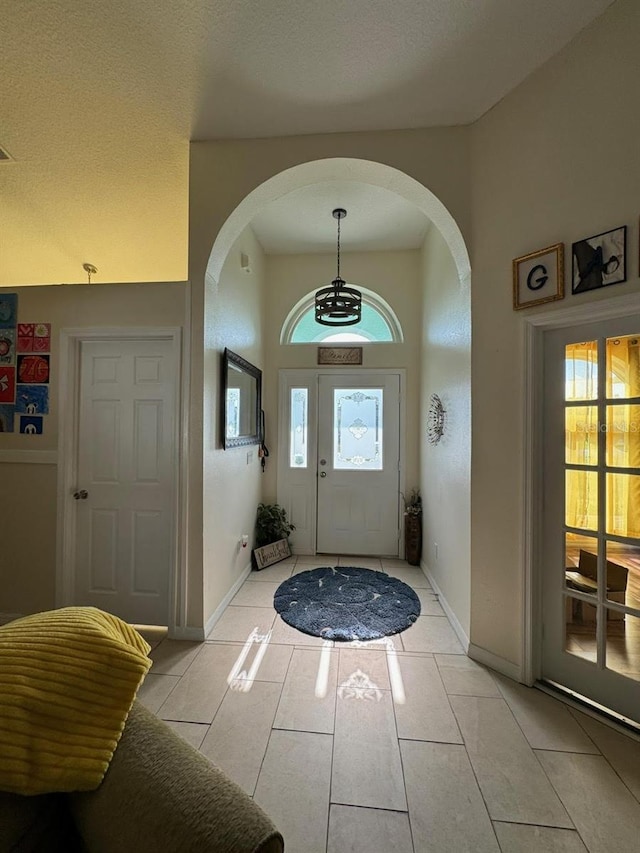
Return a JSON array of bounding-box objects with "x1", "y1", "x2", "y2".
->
[{"x1": 264, "y1": 251, "x2": 422, "y2": 500}]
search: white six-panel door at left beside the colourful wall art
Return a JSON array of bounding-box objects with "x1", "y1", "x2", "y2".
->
[{"x1": 73, "y1": 339, "x2": 177, "y2": 625}]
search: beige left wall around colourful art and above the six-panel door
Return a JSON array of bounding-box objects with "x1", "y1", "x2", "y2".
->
[{"x1": 0, "y1": 283, "x2": 186, "y2": 613}]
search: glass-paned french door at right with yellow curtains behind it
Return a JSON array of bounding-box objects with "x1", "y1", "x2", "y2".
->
[{"x1": 541, "y1": 317, "x2": 640, "y2": 723}]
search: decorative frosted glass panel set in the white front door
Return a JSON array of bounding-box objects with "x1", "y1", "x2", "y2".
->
[{"x1": 333, "y1": 388, "x2": 383, "y2": 471}]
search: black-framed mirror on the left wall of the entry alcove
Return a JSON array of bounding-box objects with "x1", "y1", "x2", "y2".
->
[{"x1": 222, "y1": 349, "x2": 262, "y2": 450}]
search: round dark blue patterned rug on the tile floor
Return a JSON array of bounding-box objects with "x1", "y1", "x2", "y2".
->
[{"x1": 273, "y1": 566, "x2": 420, "y2": 642}]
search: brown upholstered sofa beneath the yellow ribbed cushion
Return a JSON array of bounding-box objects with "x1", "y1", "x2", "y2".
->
[{"x1": 0, "y1": 701, "x2": 284, "y2": 853}]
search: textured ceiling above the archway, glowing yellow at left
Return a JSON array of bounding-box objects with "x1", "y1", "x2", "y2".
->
[{"x1": 0, "y1": 0, "x2": 611, "y2": 285}]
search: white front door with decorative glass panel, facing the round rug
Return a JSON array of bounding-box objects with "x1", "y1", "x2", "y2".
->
[{"x1": 316, "y1": 374, "x2": 400, "y2": 556}]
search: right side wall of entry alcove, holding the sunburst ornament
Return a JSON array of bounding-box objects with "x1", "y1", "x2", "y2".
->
[{"x1": 419, "y1": 223, "x2": 471, "y2": 637}]
